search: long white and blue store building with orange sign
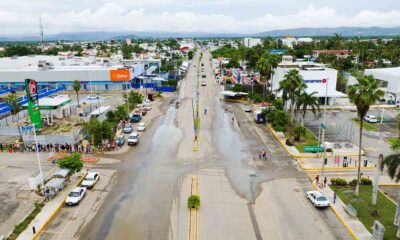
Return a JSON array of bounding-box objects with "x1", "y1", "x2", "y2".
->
[{"x1": 0, "y1": 56, "x2": 145, "y2": 91}]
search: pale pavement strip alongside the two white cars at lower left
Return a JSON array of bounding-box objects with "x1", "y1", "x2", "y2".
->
[{"x1": 39, "y1": 169, "x2": 115, "y2": 240}]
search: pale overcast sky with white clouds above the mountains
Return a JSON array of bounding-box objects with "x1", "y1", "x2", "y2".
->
[{"x1": 0, "y1": 0, "x2": 400, "y2": 35}]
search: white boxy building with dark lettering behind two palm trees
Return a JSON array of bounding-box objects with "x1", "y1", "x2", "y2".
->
[{"x1": 272, "y1": 57, "x2": 346, "y2": 105}]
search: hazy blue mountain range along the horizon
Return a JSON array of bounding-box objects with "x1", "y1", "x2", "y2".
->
[{"x1": 0, "y1": 27, "x2": 400, "y2": 42}]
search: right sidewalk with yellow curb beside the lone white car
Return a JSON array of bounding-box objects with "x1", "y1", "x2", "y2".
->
[{"x1": 313, "y1": 183, "x2": 372, "y2": 240}]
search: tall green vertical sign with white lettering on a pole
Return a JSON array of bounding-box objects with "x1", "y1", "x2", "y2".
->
[{"x1": 25, "y1": 79, "x2": 42, "y2": 129}]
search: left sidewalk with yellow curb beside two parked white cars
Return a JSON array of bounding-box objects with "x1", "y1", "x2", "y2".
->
[{"x1": 17, "y1": 174, "x2": 84, "y2": 240}]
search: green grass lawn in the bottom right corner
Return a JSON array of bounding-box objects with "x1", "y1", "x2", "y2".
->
[{"x1": 331, "y1": 185, "x2": 398, "y2": 239}]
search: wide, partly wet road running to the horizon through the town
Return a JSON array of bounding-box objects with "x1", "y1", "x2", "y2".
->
[{"x1": 80, "y1": 49, "x2": 351, "y2": 240}]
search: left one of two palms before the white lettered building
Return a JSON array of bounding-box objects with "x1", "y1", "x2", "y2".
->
[{"x1": 278, "y1": 69, "x2": 304, "y2": 124}]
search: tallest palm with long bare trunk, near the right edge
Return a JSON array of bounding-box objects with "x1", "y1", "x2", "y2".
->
[{"x1": 348, "y1": 75, "x2": 384, "y2": 196}]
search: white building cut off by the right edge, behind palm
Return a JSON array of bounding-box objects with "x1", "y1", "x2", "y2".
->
[{"x1": 364, "y1": 67, "x2": 400, "y2": 104}]
